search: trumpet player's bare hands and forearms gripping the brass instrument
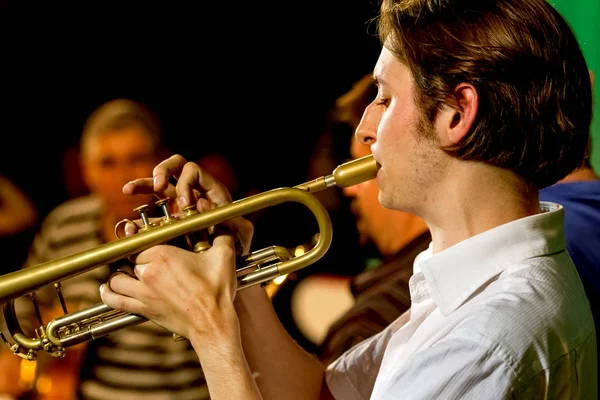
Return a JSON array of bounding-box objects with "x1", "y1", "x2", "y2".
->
[{"x1": 101, "y1": 156, "x2": 325, "y2": 399}]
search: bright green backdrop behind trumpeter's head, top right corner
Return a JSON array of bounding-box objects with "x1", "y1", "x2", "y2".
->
[{"x1": 550, "y1": 0, "x2": 600, "y2": 171}]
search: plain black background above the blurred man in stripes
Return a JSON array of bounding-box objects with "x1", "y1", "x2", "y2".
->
[{"x1": 0, "y1": 0, "x2": 379, "y2": 217}]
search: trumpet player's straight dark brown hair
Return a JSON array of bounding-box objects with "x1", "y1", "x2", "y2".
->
[{"x1": 377, "y1": 0, "x2": 592, "y2": 189}]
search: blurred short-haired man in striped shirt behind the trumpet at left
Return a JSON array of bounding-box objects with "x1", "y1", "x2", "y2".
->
[{"x1": 0, "y1": 99, "x2": 209, "y2": 400}]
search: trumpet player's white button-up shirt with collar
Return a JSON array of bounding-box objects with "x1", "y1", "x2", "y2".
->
[{"x1": 327, "y1": 202, "x2": 597, "y2": 400}]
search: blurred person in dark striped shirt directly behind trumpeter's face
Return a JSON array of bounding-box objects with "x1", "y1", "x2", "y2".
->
[{"x1": 319, "y1": 74, "x2": 431, "y2": 364}]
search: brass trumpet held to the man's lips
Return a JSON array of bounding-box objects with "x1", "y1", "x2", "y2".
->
[{"x1": 0, "y1": 156, "x2": 379, "y2": 360}]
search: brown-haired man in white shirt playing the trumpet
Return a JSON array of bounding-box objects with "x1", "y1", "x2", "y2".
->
[{"x1": 101, "y1": 0, "x2": 597, "y2": 399}]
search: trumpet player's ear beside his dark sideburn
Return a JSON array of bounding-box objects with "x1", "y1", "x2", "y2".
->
[{"x1": 438, "y1": 83, "x2": 479, "y2": 146}]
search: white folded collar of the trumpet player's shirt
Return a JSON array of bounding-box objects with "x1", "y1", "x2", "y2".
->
[{"x1": 415, "y1": 201, "x2": 565, "y2": 316}]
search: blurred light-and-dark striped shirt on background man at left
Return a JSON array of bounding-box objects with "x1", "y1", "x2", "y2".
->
[{"x1": 15, "y1": 195, "x2": 209, "y2": 400}]
